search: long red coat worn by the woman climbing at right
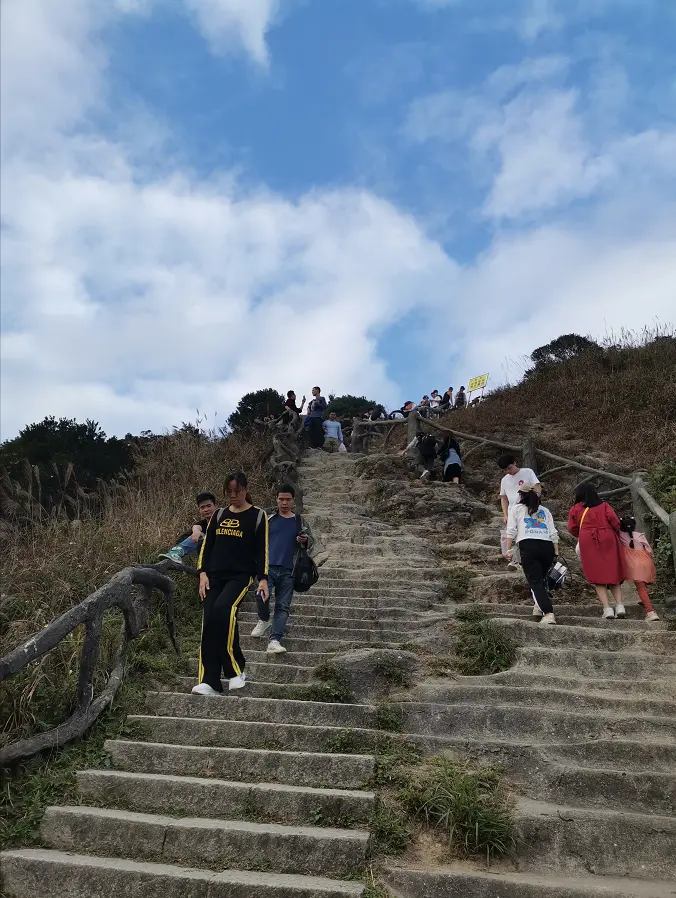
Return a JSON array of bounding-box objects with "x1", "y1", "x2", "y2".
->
[{"x1": 568, "y1": 502, "x2": 626, "y2": 586}]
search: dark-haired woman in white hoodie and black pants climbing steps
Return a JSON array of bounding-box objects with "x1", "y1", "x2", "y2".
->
[{"x1": 505, "y1": 482, "x2": 559, "y2": 624}]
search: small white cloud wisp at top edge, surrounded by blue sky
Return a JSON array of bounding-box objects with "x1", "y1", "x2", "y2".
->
[{"x1": 183, "y1": 0, "x2": 279, "y2": 66}]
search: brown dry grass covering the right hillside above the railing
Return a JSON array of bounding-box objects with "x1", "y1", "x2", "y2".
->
[{"x1": 442, "y1": 328, "x2": 676, "y2": 469}]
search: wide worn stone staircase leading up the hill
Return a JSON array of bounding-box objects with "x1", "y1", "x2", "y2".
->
[{"x1": 2, "y1": 452, "x2": 676, "y2": 898}]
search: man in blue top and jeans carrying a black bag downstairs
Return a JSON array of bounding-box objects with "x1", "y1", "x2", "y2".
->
[{"x1": 251, "y1": 483, "x2": 313, "y2": 655}]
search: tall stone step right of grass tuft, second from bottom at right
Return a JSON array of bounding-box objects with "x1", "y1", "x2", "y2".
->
[{"x1": 514, "y1": 799, "x2": 676, "y2": 886}]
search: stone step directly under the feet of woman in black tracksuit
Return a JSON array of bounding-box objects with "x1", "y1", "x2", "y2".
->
[{"x1": 146, "y1": 687, "x2": 376, "y2": 727}]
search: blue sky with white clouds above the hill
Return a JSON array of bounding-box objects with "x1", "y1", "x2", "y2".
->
[{"x1": 1, "y1": 0, "x2": 676, "y2": 437}]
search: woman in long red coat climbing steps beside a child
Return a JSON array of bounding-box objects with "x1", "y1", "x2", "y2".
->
[{"x1": 568, "y1": 483, "x2": 626, "y2": 618}]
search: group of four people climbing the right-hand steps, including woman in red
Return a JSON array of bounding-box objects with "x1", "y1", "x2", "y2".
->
[{"x1": 498, "y1": 454, "x2": 659, "y2": 624}]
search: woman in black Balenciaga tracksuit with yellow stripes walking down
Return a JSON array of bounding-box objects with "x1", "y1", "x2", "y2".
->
[{"x1": 192, "y1": 471, "x2": 268, "y2": 695}]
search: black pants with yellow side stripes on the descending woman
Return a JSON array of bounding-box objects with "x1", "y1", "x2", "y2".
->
[{"x1": 199, "y1": 574, "x2": 253, "y2": 692}]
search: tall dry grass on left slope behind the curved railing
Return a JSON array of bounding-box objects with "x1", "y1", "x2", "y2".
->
[{"x1": 0, "y1": 424, "x2": 271, "y2": 743}]
